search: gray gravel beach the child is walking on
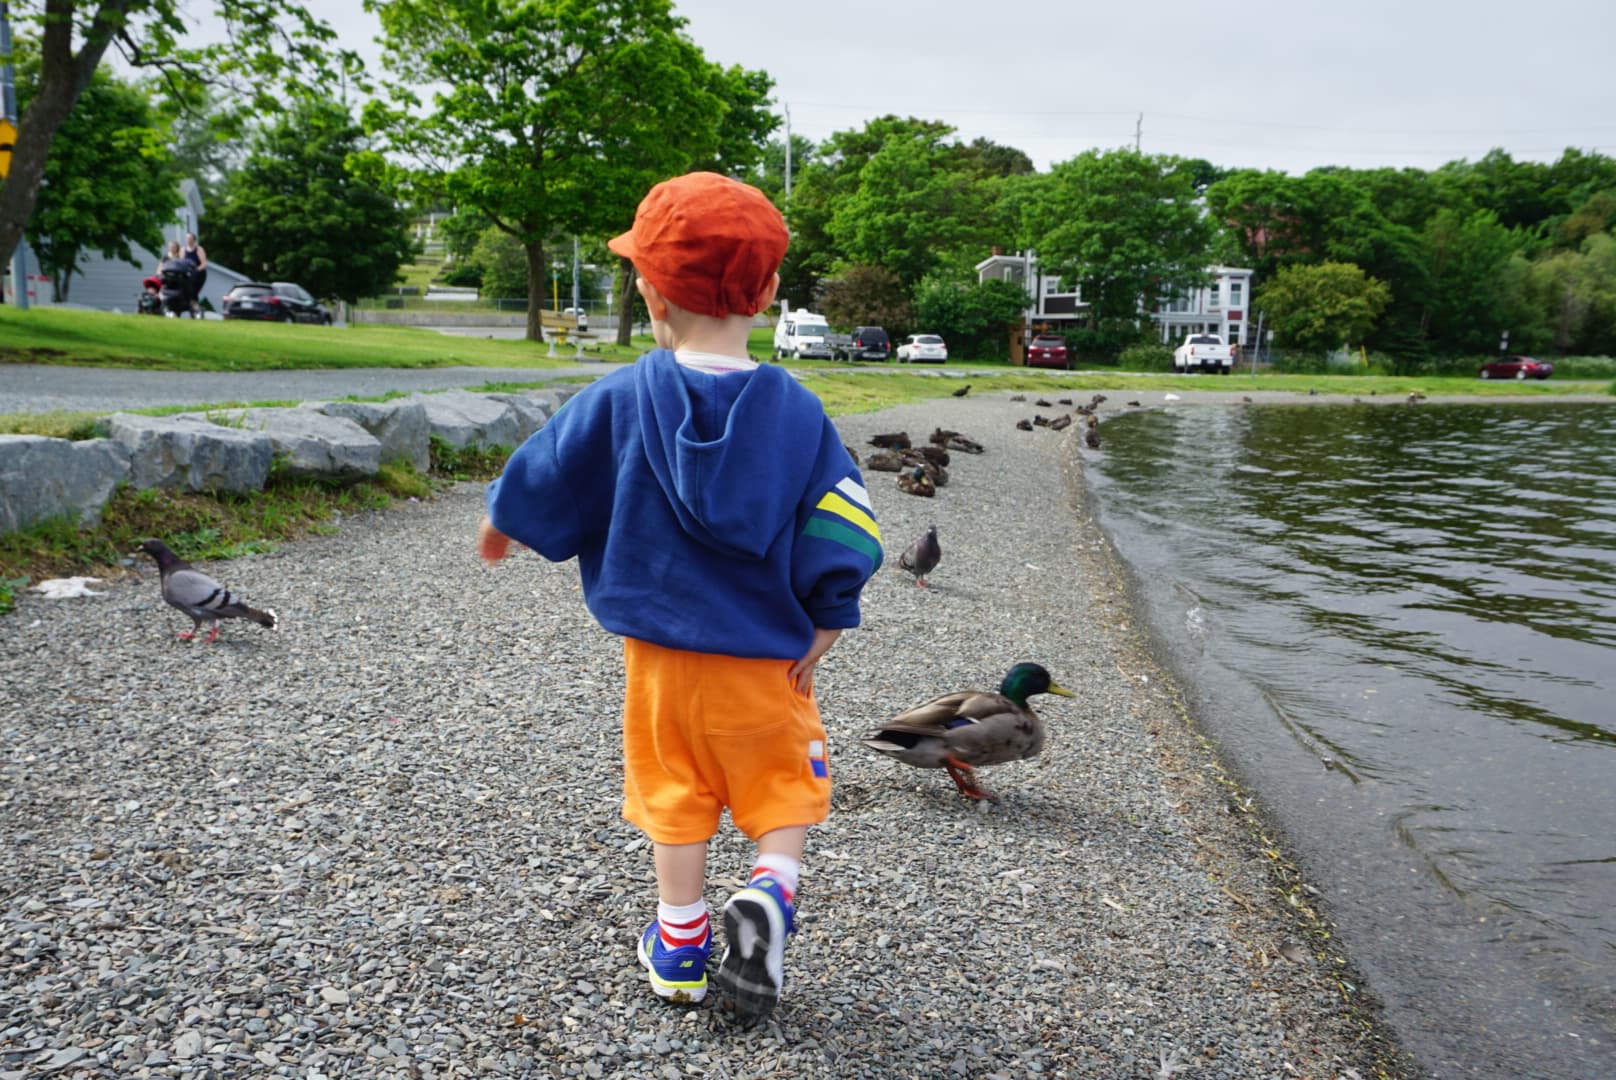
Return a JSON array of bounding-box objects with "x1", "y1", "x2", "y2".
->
[{"x1": 0, "y1": 393, "x2": 1414, "y2": 1080}]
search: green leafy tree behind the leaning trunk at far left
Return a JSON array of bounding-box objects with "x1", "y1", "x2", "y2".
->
[{"x1": 18, "y1": 57, "x2": 179, "y2": 301}]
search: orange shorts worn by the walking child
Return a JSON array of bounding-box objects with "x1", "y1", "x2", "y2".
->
[{"x1": 622, "y1": 637, "x2": 831, "y2": 844}]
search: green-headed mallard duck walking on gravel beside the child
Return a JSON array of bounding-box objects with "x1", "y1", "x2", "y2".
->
[{"x1": 865, "y1": 663, "x2": 1076, "y2": 799}]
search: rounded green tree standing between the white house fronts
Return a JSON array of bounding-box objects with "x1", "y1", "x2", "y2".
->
[{"x1": 1023, "y1": 150, "x2": 1214, "y2": 328}]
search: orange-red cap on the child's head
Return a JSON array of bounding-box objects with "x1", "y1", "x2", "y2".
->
[{"x1": 606, "y1": 173, "x2": 790, "y2": 319}]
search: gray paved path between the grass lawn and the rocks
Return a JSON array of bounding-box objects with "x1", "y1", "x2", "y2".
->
[{"x1": 0, "y1": 362, "x2": 619, "y2": 416}]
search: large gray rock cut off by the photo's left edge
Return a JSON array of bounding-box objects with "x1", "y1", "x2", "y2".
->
[{"x1": 0, "y1": 435, "x2": 129, "y2": 532}]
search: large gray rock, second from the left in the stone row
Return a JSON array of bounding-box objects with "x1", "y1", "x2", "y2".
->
[{"x1": 107, "y1": 412, "x2": 275, "y2": 491}]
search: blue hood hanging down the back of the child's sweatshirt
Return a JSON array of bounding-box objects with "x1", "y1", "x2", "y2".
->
[{"x1": 633, "y1": 349, "x2": 826, "y2": 559}]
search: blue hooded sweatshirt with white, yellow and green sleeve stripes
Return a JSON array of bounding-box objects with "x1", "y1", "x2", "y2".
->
[{"x1": 488, "y1": 349, "x2": 881, "y2": 660}]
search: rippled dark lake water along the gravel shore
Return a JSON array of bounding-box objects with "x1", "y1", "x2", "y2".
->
[{"x1": 1084, "y1": 403, "x2": 1616, "y2": 1078}]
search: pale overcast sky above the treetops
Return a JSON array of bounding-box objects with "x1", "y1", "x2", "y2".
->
[{"x1": 315, "y1": 0, "x2": 1616, "y2": 173}]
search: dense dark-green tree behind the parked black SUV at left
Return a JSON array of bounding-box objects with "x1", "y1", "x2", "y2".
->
[{"x1": 207, "y1": 102, "x2": 414, "y2": 302}]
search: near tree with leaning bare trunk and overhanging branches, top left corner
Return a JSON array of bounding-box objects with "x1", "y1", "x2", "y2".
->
[{"x1": 0, "y1": 0, "x2": 362, "y2": 282}]
